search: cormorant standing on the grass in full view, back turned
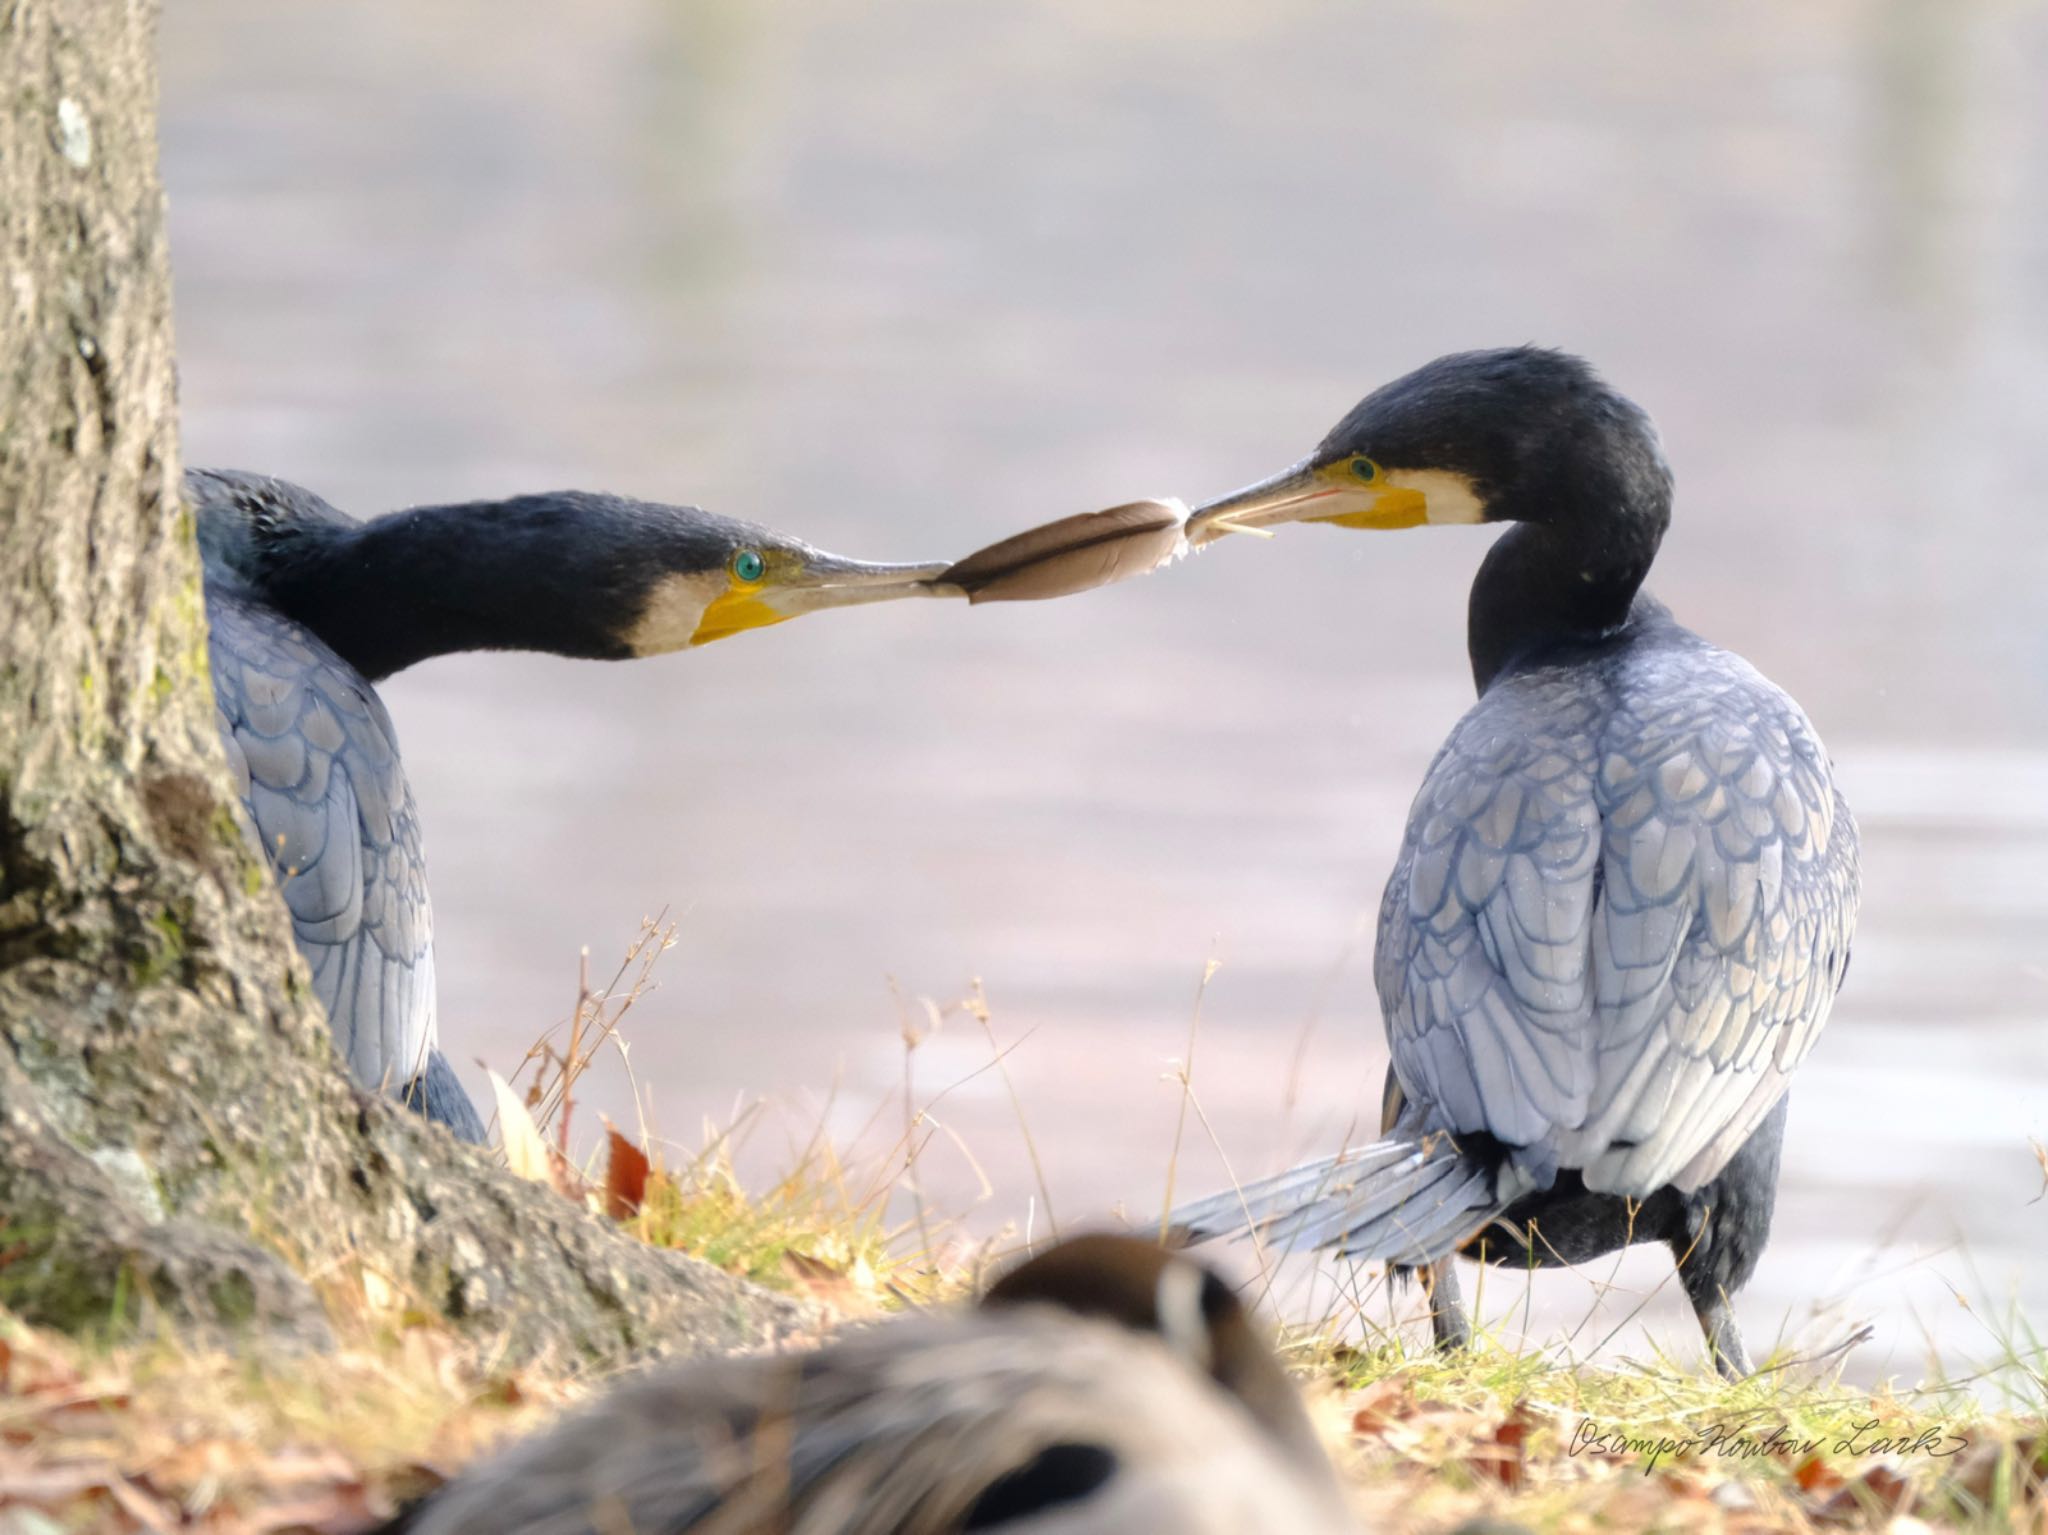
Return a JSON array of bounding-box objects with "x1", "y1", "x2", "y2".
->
[{"x1": 1176, "y1": 348, "x2": 1858, "y2": 1375}]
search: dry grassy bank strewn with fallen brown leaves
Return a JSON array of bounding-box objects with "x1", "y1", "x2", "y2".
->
[{"x1": 0, "y1": 927, "x2": 2048, "y2": 1535}]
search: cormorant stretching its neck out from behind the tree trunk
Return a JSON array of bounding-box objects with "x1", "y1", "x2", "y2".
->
[{"x1": 184, "y1": 469, "x2": 950, "y2": 1142}]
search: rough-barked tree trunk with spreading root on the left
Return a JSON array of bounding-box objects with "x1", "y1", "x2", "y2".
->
[{"x1": 0, "y1": 0, "x2": 807, "y2": 1363}]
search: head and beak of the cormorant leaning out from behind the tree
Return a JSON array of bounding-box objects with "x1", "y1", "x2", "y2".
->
[{"x1": 625, "y1": 503, "x2": 963, "y2": 655}]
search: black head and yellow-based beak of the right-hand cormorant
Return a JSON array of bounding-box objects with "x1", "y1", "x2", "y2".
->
[{"x1": 1188, "y1": 346, "x2": 1671, "y2": 546}]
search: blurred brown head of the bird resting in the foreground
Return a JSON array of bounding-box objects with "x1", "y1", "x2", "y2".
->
[{"x1": 981, "y1": 1232, "x2": 1329, "y2": 1474}]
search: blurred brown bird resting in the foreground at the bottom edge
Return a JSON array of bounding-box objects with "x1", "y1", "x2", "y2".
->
[{"x1": 383, "y1": 1236, "x2": 1356, "y2": 1535}]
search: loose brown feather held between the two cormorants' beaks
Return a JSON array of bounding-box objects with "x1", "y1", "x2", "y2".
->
[{"x1": 938, "y1": 499, "x2": 1188, "y2": 602}]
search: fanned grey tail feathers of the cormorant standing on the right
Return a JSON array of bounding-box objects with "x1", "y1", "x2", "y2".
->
[{"x1": 1167, "y1": 1134, "x2": 1505, "y2": 1267}]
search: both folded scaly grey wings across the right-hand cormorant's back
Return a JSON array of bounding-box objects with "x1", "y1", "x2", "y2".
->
[{"x1": 1376, "y1": 637, "x2": 1855, "y2": 1197}]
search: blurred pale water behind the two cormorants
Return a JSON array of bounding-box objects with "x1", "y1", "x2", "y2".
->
[{"x1": 164, "y1": 0, "x2": 2048, "y2": 1375}]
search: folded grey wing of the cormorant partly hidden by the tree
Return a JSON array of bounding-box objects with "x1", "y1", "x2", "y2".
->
[{"x1": 207, "y1": 585, "x2": 434, "y2": 1091}]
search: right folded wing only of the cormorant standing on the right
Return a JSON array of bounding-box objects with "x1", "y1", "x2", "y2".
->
[{"x1": 1565, "y1": 645, "x2": 1858, "y2": 1197}]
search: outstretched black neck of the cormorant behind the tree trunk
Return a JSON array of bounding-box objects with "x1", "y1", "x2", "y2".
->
[{"x1": 258, "y1": 491, "x2": 688, "y2": 682}]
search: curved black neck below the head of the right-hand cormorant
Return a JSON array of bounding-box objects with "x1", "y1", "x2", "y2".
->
[{"x1": 1466, "y1": 501, "x2": 1671, "y2": 692}]
